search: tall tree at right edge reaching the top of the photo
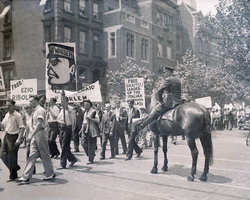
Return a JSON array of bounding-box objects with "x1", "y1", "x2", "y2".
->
[{"x1": 203, "y1": 0, "x2": 250, "y2": 103}]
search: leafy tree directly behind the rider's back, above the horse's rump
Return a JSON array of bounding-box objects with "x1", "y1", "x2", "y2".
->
[{"x1": 177, "y1": 50, "x2": 231, "y2": 104}]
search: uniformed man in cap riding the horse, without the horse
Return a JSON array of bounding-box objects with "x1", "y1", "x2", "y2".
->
[{"x1": 139, "y1": 66, "x2": 183, "y2": 130}]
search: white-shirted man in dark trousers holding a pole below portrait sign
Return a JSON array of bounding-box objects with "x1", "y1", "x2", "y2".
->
[{"x1": 57, "y1": 97, "x2": 78, "y2": 169}]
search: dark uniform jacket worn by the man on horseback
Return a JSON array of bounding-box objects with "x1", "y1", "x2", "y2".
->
[{"x1": 158, "y1": 75, "x2": 183, "y2": 107}]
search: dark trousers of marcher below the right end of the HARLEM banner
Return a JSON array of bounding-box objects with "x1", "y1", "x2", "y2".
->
[{"x1": 81, "y1": 133, "x2": 97, "y2": 162}]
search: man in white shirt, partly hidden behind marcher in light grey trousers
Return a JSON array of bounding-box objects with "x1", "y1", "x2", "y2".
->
[{"x1": 48, "y1": 98, "x2": 60, "y2": 158}]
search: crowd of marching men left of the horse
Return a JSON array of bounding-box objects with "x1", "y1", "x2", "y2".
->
[{"x1": 1, "y1": 96, "x2": 152, "y2": 184}]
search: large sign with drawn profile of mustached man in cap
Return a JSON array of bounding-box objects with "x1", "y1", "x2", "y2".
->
[{"x1": 46, "y1": 43, "x2": 76, "y2": 97}]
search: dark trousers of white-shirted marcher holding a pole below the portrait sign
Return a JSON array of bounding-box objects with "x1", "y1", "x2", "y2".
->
[{"x1": 59, "y1": 126, "x2": 76, "y2": 167}]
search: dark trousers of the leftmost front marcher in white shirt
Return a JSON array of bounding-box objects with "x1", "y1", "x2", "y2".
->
[{"x1": 1, "y1": 133, "x2": 20, "y2": 179}]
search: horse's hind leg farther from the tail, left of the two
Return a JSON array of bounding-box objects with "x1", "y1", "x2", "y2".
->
[{"x1": 187, "y1": 138, "x2": 199, "y2": 181}]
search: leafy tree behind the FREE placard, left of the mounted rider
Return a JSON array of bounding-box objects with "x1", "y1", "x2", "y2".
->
[{"x1": 106, "y1": 59, "x2": 155, "y2": 99}]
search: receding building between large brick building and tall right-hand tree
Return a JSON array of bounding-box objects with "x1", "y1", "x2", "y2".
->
[{"x1": 178, "y1": 0, "x2": 220, "y2": 66}]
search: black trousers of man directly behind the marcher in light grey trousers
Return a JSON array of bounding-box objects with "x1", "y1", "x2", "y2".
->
[{"x1": 49, "y1": 122, "x2": 60, "y2": 157}]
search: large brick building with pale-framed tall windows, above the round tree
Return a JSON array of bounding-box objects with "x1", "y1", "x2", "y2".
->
[{"x1": 103, "y1": 0, "x2": 177, "y2": 74}]
